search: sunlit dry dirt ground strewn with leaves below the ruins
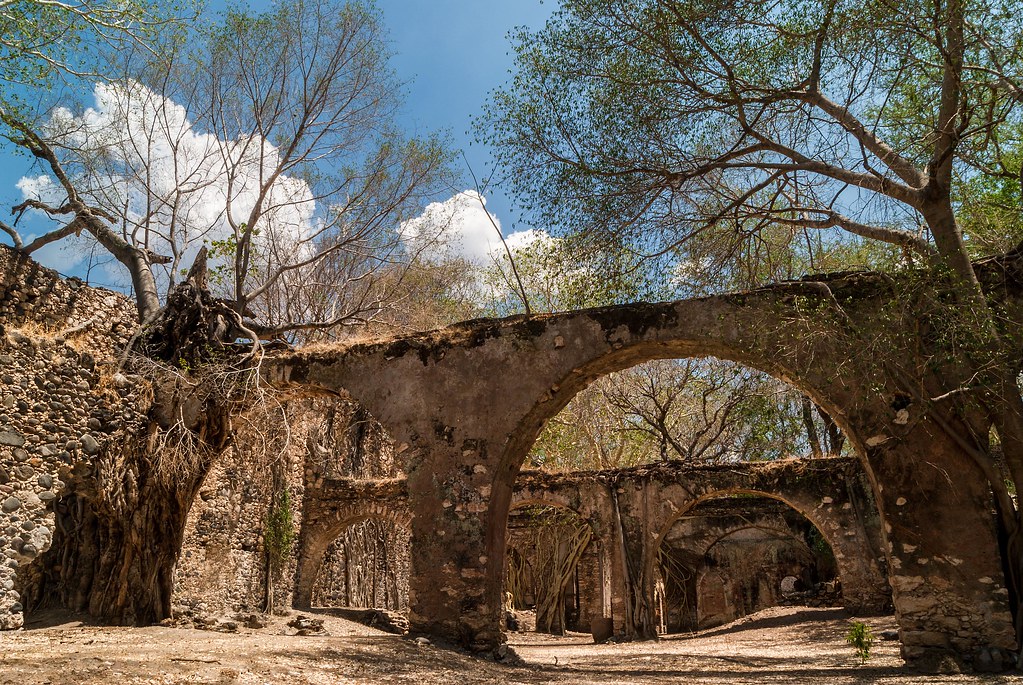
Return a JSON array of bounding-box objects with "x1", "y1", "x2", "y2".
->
[{"x1": 0, "y1": 607, "x2": 1020, "y2": 685}]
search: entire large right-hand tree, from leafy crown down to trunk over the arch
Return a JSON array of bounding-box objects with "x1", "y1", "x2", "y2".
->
[{"x1": 480, "y1": 0, "x2": 1023, "y2": 646}]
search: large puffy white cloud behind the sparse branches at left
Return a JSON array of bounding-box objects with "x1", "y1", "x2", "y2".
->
[{"x1": 17, "y1": 82, "x2": 317, "y2": 282}]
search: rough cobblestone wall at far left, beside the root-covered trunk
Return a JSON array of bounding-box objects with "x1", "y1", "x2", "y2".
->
[{"x1": 0, "y1": 246, "x2": 147, "y2": 629}]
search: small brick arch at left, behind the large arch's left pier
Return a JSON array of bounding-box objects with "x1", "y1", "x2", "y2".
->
[{"x1": 293, "y1": 500, "x2": 412, "y2": 608}]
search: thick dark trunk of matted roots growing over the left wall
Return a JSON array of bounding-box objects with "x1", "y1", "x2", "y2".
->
[{"x1": 31, "y1": 261, "x2": 237, "y2": 625}]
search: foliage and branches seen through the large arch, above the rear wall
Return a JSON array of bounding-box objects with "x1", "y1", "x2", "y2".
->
[{"x1": 530, "y1": 359, "x2": 827, "y2": 471}]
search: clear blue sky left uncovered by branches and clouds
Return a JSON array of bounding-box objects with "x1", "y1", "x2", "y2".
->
[{"x1": 0, "y1": 0, "x2": 558, "y2": 278}]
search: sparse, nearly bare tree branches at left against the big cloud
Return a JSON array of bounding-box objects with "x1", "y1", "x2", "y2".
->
[{"x1": 8, "y1": 2, "x2": 449, "y2": 337}]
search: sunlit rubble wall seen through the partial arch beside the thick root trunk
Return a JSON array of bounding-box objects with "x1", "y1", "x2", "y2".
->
[{"x1": 174, "y1": 397, "x2": 408, "y2": 613}]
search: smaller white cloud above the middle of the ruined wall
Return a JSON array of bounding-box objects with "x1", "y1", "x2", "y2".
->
[{"x1": 401, "y1": 190, "x2": 546, "y2": 266}]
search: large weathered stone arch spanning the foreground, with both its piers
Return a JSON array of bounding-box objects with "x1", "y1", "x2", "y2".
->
[{"x1": 266, "y1": 275, "x2": 1015, "y2": 659}]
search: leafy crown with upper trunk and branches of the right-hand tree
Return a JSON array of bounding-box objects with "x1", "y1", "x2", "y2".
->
[{"x1": 484, "y1": 0, "x2": 1020, "y2": 276}]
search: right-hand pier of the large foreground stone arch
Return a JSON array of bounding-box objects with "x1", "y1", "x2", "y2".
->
[{"x1": 869, "y1": 418, "x2": 1016, "y2": 668}]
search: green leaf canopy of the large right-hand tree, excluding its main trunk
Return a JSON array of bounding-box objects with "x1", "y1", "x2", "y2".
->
[{"x1": 477, "y1": 0, "x2": 1023, "y2": 290}]
